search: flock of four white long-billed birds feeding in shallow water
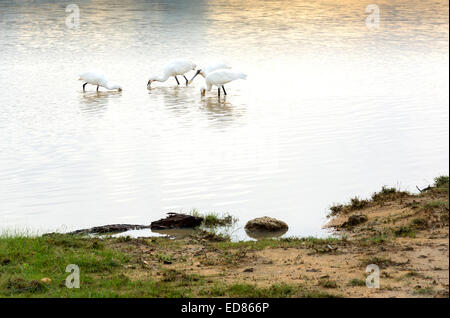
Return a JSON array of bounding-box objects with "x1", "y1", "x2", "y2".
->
[{"x1": 79, "y1": 59, "x2": 247, "y2": 96}]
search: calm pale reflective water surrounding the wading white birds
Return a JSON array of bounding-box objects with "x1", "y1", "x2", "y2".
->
[{"x1": 0, "y1": 0, "x2": 449, "y2": 236}]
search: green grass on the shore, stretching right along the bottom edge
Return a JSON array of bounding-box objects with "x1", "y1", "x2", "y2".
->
[{"x1": 0, "y1": 234, "x2": 338, "y2": 298}]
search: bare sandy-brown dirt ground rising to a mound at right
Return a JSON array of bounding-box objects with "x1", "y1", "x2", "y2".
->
[{"x1": 108, "y1": 185, "x2": 449, "y2": 297}]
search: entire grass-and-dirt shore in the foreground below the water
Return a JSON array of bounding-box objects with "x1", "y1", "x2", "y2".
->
[{"x1": 0, "y1": 177, "x2": 449, "y2": 297}]
